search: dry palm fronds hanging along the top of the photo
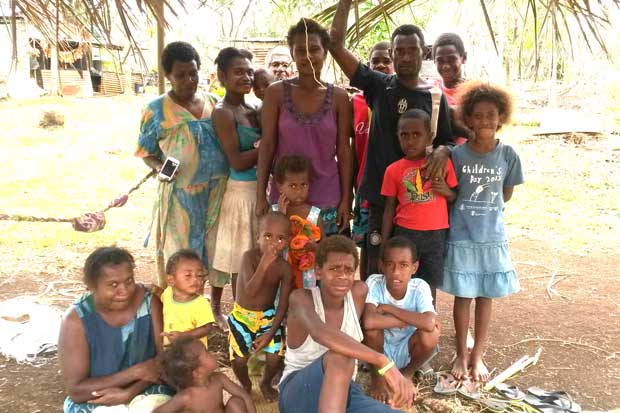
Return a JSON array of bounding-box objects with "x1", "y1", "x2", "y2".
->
[{"x1": 11, "y1": 0, "x2": 620, "y2": 71}]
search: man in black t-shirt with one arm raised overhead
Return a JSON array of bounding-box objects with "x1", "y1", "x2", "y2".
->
[{"x1": 330, "y1": 0, "x2": 453, "y2": 274}]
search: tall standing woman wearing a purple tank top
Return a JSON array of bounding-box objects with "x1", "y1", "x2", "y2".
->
[{"x1": 256, "y1": 18, "x2": 352, "y2": 235}]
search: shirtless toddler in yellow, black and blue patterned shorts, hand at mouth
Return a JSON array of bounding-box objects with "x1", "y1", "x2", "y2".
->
[{"x1": 228, "y1": 211, "x2": 292, "y2": 401}]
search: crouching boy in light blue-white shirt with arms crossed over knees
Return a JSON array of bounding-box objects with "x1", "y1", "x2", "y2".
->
[{"x1": 362, "y1": 237, "x2": 439, "y2": 403}]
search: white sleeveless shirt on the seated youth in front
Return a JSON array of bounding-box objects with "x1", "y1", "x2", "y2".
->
[{"x1": 280, "y1": 287, "x2": 364, "y2": 383}]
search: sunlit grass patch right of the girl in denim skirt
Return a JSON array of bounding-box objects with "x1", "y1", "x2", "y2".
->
[{"x1": 502, "y1": 127, "x2": 620, "y2": 253}]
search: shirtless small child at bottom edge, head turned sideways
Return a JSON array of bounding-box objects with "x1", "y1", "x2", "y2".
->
[{"x1": 153, "y1": 337, "x2": 256, "y2": 413}]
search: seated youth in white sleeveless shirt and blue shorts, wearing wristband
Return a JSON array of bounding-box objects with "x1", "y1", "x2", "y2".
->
[{"x1": 279, "y1": 235, "x2": 415, "y2": 413}]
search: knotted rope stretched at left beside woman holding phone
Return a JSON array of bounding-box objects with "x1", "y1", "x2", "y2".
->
[{"x1": 0, "y1": 170, "x2": 156, "y2": 232}]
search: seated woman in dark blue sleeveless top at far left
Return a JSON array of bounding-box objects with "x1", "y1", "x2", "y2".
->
[{"x1": 58, "y1": 247, "x2": 173, "y2": 413}]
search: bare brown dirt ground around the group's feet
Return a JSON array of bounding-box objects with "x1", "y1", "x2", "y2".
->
[{"x1": 0, "y1": 232, "x2": 620, "y2": 413}]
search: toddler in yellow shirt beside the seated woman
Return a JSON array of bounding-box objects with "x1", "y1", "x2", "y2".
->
[{"x1": 161, "y1": 249, "x2": 216, "y2": 348}]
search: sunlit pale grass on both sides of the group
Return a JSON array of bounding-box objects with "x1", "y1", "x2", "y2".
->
[{"x1": 0, "y1": 96, "x2": 620, "y2": 255}]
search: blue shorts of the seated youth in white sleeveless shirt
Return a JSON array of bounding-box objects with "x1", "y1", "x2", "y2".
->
[{"x1": 278, "y1": 356, "x2": 403, "y2": 413}]
